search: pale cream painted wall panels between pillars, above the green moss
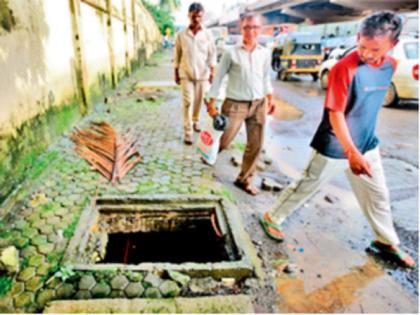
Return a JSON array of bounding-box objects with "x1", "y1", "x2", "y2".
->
[{"x1": 0, "y1": 0, "x2": 161, "y2": 136}]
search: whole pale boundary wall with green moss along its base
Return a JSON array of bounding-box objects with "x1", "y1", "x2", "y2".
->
[{"x1": 0, "y1": 0, "x2": 161, "y2": 203}]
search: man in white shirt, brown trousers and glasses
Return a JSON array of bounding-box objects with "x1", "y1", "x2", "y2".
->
[{"x1": 208, "y1": 13, "x2": 275, "y2": 195}]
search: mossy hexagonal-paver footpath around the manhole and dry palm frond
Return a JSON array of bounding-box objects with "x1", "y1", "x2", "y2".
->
[{"x1": 0, "y1": 54, "x2": 233, "y2": 312}]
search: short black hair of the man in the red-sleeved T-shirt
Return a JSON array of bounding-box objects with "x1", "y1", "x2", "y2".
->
[{"x1": 359, "y1": 11, "x2": 402, "y2": 40}]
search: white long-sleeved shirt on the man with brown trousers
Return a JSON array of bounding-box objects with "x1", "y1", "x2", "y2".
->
[{"x1": 207, "y1": 44, "x2": 273, "y2": 101}]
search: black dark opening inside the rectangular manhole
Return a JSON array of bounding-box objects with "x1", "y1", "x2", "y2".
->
[{"x1": 102, "y1": 218, "x2": 231, "y2": 264}]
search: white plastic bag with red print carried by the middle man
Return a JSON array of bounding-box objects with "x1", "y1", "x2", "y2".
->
[{"x1": 197, "y1": 115, "x2": 223, "y2": 165}]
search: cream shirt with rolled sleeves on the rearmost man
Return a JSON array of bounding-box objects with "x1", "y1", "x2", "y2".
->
[{"x1": 174, "y1": 27, "x2": 216, "y2": 81}]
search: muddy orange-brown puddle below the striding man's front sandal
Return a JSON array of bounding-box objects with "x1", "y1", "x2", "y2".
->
[{"x1": 277, "y1": 259, "x2": 384, "y2": 313}]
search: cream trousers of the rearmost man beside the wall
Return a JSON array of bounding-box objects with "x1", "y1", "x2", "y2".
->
[{"x1": 181, "y1": 79, "x2": 208, "y2": 136}]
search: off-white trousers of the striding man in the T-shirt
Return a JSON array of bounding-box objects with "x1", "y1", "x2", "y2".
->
[{"x1": 269, "y1": 148, "x2": 399, "y2": 245}]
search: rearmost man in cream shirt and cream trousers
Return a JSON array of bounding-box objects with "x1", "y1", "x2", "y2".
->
[{"x1": 174, "y1": 2, "x2": 216, "y2": 145}]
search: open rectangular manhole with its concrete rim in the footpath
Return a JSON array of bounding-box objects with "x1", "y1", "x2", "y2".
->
[{"x1": 64, "y1": 196, "x2": 259, "y2": 279}]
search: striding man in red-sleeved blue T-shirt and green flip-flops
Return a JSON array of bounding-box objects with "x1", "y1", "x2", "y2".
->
[{"x1": 260, "y1": 12, "x2": 415, "y2": 267}]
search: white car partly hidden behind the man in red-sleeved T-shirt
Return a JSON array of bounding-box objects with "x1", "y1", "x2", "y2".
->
[{"x1": 319, "y1": 37, "x2": 419, "y2": 106}]
